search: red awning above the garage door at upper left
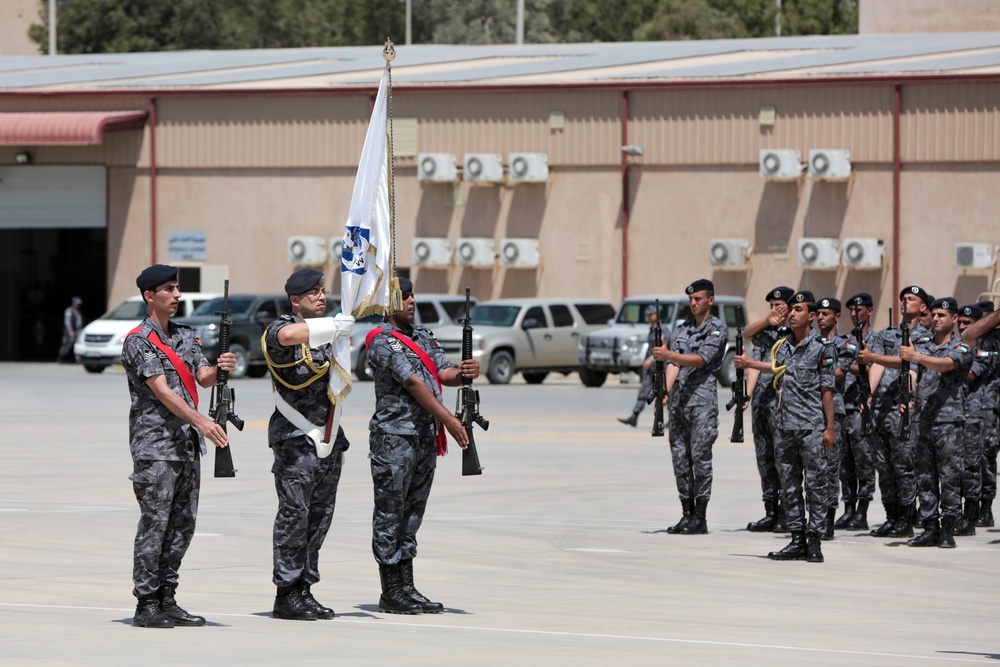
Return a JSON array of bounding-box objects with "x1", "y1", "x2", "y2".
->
[{"x1": 0, "y1": 111, "x2": 148, "y2": 146}]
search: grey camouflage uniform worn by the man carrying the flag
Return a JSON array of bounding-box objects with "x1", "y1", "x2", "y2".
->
[{"x1": 262, "y1": 315, "x2": 349, "y2": 588}]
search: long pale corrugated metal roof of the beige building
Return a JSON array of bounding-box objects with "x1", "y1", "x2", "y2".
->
[{"x1": 0, "y1": 32, "x2": 1000, "y2": 91}]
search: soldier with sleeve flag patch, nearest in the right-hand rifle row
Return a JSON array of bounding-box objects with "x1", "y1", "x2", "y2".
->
[{"x1": 899, "y1": 298, "x2": 973, "y2": 549}]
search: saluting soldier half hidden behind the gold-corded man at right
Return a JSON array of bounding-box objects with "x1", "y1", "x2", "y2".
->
[{"x1": 743, "y1": 285, "x2": 795, "y2": 533}]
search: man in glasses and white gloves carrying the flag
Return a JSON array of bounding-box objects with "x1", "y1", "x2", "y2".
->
[{"x1": 261, "y1": 269, "x2": 354, "y2": 621}]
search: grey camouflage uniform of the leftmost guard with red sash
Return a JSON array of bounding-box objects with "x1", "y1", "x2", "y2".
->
[{"x1": 122, "y1": 317, "x2": 208, "y2": 597}]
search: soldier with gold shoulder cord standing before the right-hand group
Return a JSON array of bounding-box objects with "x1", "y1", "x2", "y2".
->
[{"x1": 736, "y1": 291, "x2": 837, "y2": 563}]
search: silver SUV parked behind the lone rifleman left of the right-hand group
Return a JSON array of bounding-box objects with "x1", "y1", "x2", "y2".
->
[{"x1": 577, "y1": 294, "x2": 747, "y2": 387}]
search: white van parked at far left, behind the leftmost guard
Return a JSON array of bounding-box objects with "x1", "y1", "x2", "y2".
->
[{"x1": 73, "y1": 292, "x2": 219, "y2": 373}]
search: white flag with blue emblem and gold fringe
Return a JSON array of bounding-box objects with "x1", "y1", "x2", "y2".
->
[{"x1": 330, "y1": 67, "x2": 392, "y2": 403}]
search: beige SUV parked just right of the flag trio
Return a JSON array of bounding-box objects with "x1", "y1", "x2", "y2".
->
[{"x1": 435, "y1": 298, "x2": 615, "y2": 384}]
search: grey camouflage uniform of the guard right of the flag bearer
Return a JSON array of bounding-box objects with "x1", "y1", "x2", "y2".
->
[{"x1": 368, "y1": 322, "x2": 453, "y2": 565}]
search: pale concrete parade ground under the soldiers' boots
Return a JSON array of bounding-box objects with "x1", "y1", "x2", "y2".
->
[{"x1": 0, "y1": 364, "x2": 1000, "y2": 667}]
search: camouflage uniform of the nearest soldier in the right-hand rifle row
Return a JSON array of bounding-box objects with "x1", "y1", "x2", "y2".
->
[{"x1": 913, "y1": 336, "x2": 973, "y2": 525}]
